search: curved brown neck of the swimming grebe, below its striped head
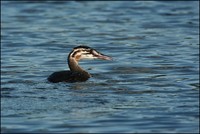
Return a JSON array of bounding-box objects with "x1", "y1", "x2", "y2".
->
[{"x1": 68, "y1": 58, "x2": 91, "y2": 77}]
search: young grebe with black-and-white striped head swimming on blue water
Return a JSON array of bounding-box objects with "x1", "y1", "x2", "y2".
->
[{"x1": 48, "y1": 46, "x2": 112, "y2": 83}]
